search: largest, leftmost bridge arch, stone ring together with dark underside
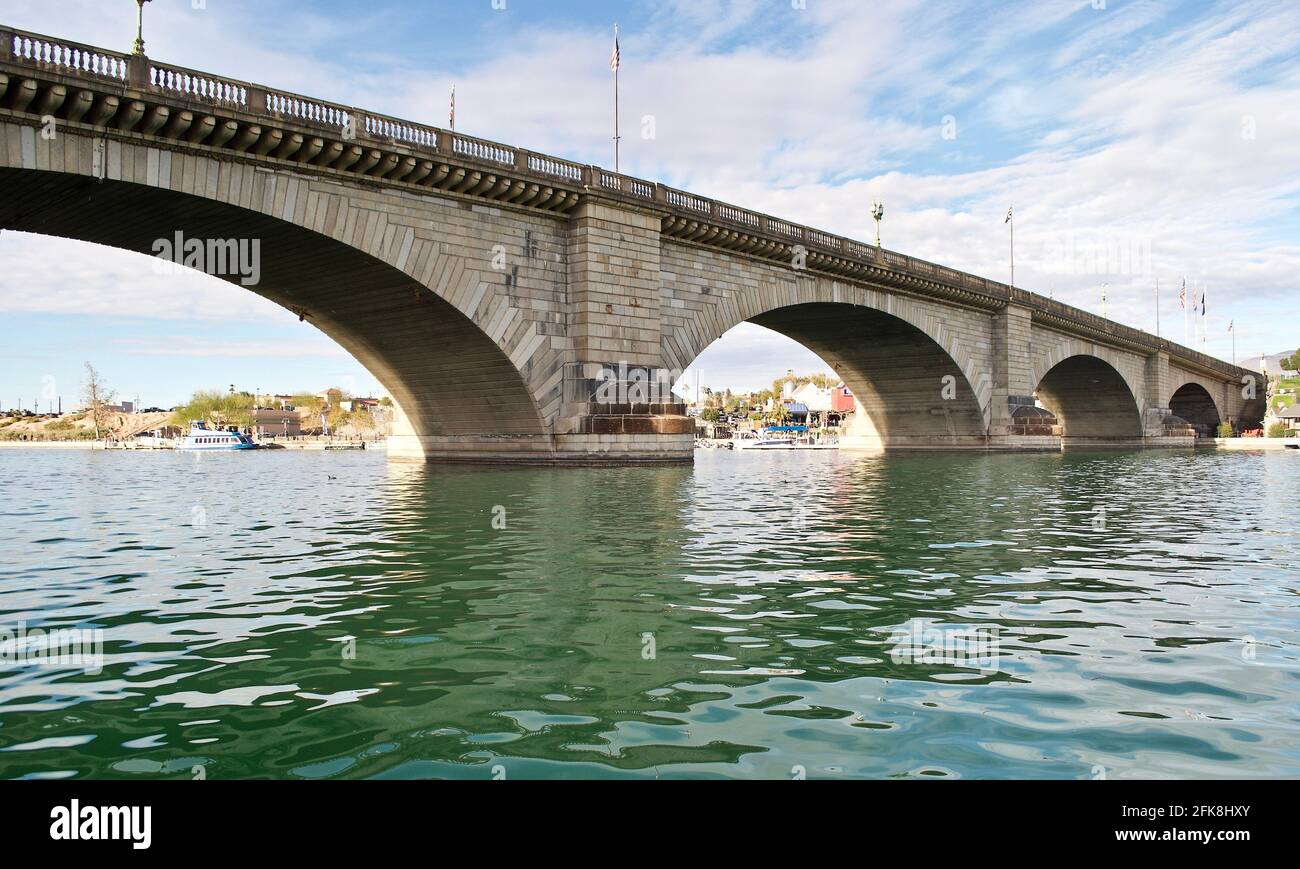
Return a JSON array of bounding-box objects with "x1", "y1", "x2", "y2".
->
[{"x1": 0, "y1": 130, "x2": 549, "y2": 458}]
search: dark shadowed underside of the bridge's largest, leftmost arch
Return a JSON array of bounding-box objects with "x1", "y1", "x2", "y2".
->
[{"x1": 0, "y1": 168, "x2": 546, "y2": 437}]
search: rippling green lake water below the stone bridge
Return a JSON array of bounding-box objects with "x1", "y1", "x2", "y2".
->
[{"x1": 0, "y1": 450, "x2": 1300, "y2": 779}]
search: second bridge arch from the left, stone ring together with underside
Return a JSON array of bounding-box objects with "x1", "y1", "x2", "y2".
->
[{"x1": 663, "y1": 265, "x2": 991, "y2": 449}]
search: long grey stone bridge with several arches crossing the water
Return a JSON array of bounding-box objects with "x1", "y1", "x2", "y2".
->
[{"x1": 0, "y1": 27, "x2": 1264, "y2": 462}]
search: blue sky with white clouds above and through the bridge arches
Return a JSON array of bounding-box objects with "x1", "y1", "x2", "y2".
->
[{"x1": 0, "y1": 0, "x2": 1300, "y2": 407}]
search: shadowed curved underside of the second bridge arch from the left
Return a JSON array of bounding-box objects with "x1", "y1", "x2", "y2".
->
[{"x1": 749, "y1": 302, "x2": 988, "y2": 449}]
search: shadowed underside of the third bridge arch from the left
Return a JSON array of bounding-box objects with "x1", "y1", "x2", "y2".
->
[{"x1": 1036, "y1": 355, "x2": 1143, "y2": 446}]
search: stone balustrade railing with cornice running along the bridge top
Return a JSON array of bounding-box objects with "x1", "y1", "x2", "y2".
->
[{"x1": 0, "y1": 27, "x2": 1245, "y2": 379}]
